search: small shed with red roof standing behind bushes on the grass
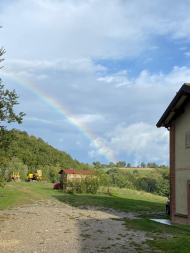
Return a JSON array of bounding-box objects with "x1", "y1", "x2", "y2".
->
[{"x1": 59, "y1": 169, "x2": 94, "y2": 189}]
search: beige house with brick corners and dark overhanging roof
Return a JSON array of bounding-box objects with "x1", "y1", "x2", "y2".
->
[{"x1": 157, "y1": 83, "x2": 190, "y2": 224}]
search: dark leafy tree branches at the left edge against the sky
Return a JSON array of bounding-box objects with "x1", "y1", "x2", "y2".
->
[{"x1": 0, "y1": 30, "x2": 25, "y2": 128}]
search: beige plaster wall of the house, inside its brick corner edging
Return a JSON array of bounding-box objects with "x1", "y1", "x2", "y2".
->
[{"x1": 175, "y1": 103, "x2": 190, "y2": 214}]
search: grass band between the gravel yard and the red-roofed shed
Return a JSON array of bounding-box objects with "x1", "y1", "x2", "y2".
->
[{"x1": 0, "y1": 182, "x2": 166, "y2": 211}]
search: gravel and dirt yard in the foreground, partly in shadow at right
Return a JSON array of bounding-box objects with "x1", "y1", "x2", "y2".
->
[{"x1": 0, "y1": 199, "x2": 154, "y2": 253}]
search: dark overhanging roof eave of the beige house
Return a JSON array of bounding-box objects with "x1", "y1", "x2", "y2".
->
[{"x1": 156, "y1": 83, "x2": 190, "y2": 128}]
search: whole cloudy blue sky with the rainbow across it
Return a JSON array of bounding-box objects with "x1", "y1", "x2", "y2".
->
[{"x1": 0, "y1": 0, "x2": 190, "y2": 166}]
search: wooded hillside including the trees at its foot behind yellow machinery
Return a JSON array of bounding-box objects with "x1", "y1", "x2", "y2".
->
[{"x1": 0, "y1": 129, "x2": 89, "y2": 182}]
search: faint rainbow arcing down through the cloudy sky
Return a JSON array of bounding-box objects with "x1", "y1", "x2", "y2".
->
[{"x1": 2, "y1": 70, "x2": 116, "y2": 163}]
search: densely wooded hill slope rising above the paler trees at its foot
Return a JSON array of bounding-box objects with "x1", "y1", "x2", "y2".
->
[{"x1": 0, "y1": 129, "x2": 89, "y2": 169}]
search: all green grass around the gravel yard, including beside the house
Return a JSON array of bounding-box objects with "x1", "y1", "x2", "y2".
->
[{"x1": 0, "y1": 182, "x2": 190, "y2": 253}]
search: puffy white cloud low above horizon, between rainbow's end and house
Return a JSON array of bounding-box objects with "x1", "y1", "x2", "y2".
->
[{"x1": 89, "y1": 122, "x2": 169, "y2": 165}]
